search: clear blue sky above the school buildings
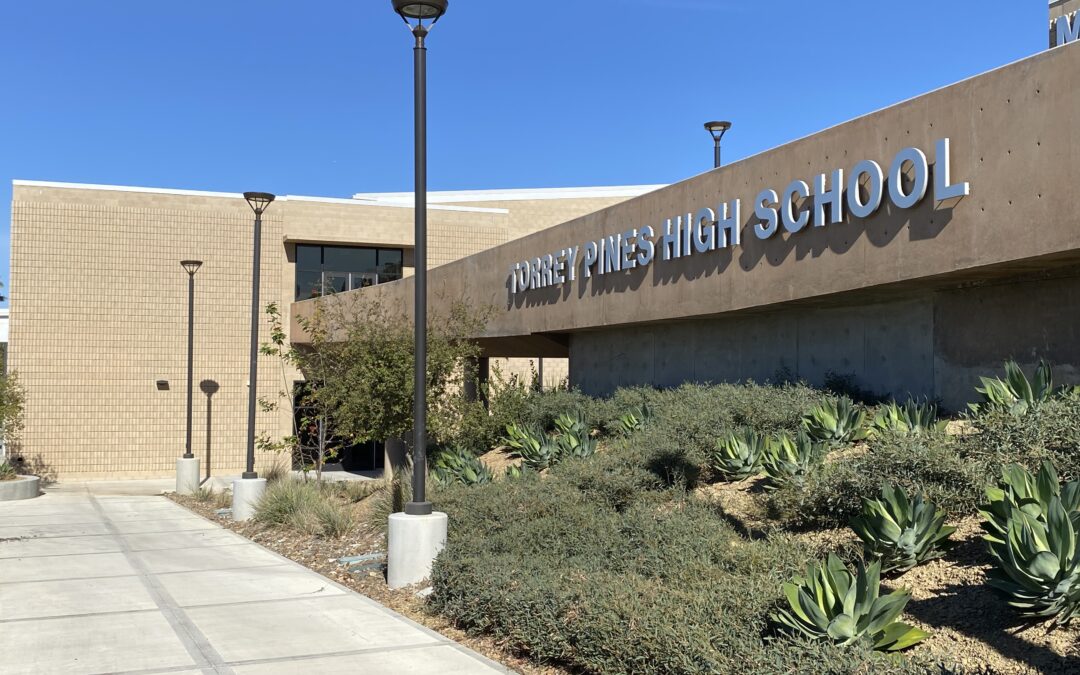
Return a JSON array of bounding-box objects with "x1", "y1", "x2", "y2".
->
[{"x1": 0, "y1": 0, "x2": 1047, "y2": 300}]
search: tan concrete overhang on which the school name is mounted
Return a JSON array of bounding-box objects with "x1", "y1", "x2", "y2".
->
[{"x1": 293, "y1": 45, "x2": 1080, "y2": 355}]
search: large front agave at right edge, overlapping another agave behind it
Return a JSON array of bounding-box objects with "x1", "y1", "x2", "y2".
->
[{"x1": 984, "y1": 495, "x2": 1080, "y2": 625}]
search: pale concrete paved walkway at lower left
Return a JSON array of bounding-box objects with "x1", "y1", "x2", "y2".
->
[{"x1": 0, "y1": 484, "x2": 507, "y2": 675}]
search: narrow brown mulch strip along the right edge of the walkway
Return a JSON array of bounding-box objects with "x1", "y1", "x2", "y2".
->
[{"x1": 167, "y1": 495, "x2": 567, "y2": 675}]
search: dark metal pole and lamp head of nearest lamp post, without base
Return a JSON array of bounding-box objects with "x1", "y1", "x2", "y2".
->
[{"x1": 392, "y1": 0, "x2": 449, "y2": 515}]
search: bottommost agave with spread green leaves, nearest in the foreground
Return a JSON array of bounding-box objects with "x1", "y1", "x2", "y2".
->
[{"x1": 773, "y1": 553, "x2": 930, "y2": 651}]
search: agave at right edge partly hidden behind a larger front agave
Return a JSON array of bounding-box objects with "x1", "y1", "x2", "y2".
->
[{"x1": 980, "y1": 461, "x2": 1080, "y2": 538}]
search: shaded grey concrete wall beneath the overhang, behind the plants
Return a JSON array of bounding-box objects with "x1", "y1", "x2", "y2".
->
[{"x1": 570, "y1": 269, "x2": 1080, "y2": 410}]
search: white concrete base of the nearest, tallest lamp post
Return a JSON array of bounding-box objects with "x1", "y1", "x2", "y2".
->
[{"x1": 387, "y1": 511, "x2": 449, "y2": 589}]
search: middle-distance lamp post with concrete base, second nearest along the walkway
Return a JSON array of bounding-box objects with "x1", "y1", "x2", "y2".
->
[{"x1": 232, "y1": 192, "x2": 274, "y2": 521}]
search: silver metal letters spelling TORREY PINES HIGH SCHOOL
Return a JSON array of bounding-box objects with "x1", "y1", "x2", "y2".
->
[{"x1": 509, "y1": 138, "x2": 972, "y2": 295}]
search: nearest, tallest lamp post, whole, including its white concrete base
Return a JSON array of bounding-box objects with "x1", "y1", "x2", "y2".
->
[{"x1": 387, "y1": 0, "x2": 449, "y2": 588}]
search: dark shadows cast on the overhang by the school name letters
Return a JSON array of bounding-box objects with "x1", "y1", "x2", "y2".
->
[{"x1": 505, "y1": 170, "x2": 953, "y2": 309}]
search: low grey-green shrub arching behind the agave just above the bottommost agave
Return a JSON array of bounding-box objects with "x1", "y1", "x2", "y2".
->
[{"x1": 767, "y1": 436, "x2": 988, "y2": 528}]
